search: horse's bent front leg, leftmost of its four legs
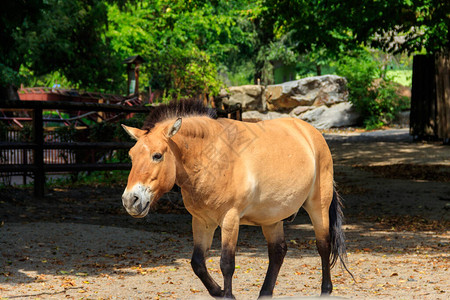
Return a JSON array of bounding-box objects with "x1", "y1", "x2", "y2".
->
[{"x1": 191, "y1": 217, "x2": 223, "y2": 297}]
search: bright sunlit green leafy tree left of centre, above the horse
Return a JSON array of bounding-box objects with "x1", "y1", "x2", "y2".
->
[{"x1": 107, "y1": 0, "x2": 255, "y2": 97}]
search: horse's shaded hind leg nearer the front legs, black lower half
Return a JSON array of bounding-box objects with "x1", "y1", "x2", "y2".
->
[{"x1": 259, "y1": 221, "x2": 287, "y2": 297}]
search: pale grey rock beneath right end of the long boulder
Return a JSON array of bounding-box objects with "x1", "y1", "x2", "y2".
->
[{"x1": 299, "y1": 102, "x2": 360, "y2": 129}]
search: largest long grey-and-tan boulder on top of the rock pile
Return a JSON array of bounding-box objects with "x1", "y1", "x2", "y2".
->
[{"x1": 266, "y1": 75, "x2": 348, "y2": 111}]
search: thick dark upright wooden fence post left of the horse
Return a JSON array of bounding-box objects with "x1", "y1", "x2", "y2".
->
[{"x1": 33, "y1": 107, "x2": 45, "y2": 198}]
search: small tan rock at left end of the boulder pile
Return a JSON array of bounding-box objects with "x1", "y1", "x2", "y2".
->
[{"x1": 220, "y1": 85, "x2": 266, "y2": 111}]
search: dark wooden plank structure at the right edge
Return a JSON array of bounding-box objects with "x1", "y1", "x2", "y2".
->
[{"x1": 410, "y1": 55, "x2": 450, "y2": 143}]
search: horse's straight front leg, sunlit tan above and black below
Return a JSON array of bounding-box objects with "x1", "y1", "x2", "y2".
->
[{"x1": 220, "y1": 211, "x2": 239, "y2": 299}]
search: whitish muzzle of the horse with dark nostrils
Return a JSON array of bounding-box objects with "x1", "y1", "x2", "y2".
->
[{"x1": 122, "y1": 184, "x2": 152, "y2": 218}]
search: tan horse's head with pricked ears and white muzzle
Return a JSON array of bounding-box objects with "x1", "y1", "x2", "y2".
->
[{"x1": 122, "y1": 118, "x2": 181, "y2": 218}]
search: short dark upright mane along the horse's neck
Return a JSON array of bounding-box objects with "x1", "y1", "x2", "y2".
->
[{"x1": 142, "y1": 100, "x2": 216, "y2": 131}]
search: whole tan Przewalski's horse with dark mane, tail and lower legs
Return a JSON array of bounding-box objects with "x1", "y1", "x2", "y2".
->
[{"x1": 122, "y1": 101, "x2": 345, "y2": 298}]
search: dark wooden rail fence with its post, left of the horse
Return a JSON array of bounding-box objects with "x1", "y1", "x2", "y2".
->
[{"x1": 0, "y1": 101, "x2": 152, "y2": 198}]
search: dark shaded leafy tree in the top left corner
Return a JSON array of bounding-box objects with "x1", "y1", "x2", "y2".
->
[{"x1": 0, "y1": 0, "x2": 128, "y2": 99}]
